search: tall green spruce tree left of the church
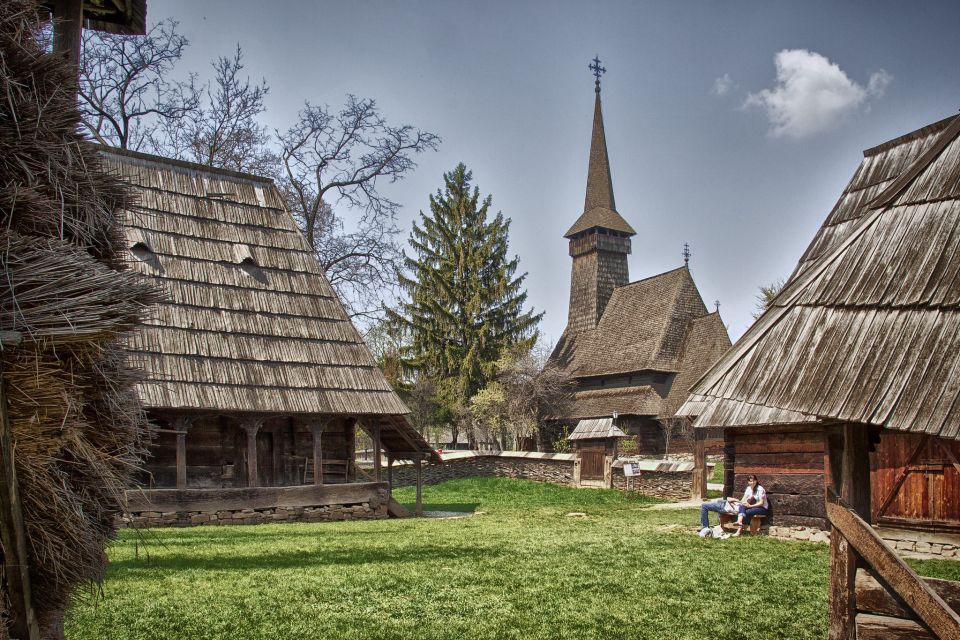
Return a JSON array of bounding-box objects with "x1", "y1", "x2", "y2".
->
[{"x1": 393, "y1": 163, "x2": 543, "y2": 428}]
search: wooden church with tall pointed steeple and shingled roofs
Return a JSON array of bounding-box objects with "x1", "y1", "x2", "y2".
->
[{"x1": 551, "y1": 69, "x2": 730, "y2": 453}]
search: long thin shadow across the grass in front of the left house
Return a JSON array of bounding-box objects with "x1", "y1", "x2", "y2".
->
[{"x1": 110, "y1": 545, "x2": 503, "y2": 573}]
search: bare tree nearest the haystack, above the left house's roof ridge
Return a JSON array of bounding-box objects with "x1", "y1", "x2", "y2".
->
[{"x1": 80, "y1": 18, "x2": 198, "y2": 151}]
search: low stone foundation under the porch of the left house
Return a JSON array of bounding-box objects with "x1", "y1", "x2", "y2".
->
[{"x1": 116, "y1": 502, "x2": 387, "y2": 529}]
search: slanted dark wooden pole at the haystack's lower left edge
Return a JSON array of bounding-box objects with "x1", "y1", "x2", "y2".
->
[{"x1": 0, "y1": 378, "x2": 40, "y2": 640}]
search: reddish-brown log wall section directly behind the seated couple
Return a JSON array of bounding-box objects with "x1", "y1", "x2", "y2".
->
[{"x1": 729, "y1": 427, "x2": 827, "y2": 529}]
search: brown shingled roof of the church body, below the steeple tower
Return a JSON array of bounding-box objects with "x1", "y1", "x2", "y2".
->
[{"x1": 552, "y1": 266, "x2": 730, "y2": 417}]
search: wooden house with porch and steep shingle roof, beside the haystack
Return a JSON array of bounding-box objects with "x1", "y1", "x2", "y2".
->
[{"x1": 102, "y1": 148, "x2": 437, "y2": 502}]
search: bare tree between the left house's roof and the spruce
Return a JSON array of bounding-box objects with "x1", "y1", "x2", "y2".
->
[{"x1": 276, "y1": 95, "x2": 440, "y2": 319}]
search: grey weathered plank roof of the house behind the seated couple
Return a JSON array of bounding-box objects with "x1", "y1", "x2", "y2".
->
[{"x1": 681, "y1": 116, "x2": 960, "y2": 439}]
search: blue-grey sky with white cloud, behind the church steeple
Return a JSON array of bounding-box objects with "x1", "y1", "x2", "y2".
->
[{"x1": 158, "y1": 0, "x2": 960, "y2": 341}]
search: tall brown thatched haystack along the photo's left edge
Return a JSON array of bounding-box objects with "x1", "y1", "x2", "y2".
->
[{"x1": 0, "y1": 0, "x2": 155, "y2": 637}]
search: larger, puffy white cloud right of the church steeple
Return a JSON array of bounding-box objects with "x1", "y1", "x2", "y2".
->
[{"x1": 743, "y1": 49, "x2": 893, "y2": 138}]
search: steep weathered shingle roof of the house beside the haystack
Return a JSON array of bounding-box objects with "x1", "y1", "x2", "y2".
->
[{"x1": 102, "y1": 148, "x2": 430, "y2": 460}]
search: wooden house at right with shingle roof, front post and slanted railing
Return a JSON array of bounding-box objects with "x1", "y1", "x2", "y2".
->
[{"x1": 680, "y1": 116, "x2": 960, "y2": 638}]
